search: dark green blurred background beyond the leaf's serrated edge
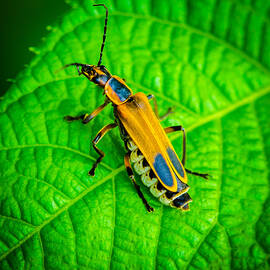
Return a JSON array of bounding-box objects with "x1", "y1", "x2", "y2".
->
[{"x1": 0, "y1": 0, "x2": 69, "y2": 96}]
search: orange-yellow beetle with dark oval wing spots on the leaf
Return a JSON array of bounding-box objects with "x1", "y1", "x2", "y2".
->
[{"x1": 64, "y1": 4, "x2": 209, "y2": 212}]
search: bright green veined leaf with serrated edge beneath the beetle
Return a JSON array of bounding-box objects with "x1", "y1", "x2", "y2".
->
[{"x1": 0, "y1": 0, "x2": 270, "y2": 269}]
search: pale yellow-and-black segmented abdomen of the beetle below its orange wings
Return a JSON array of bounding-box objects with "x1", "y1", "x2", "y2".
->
[{"x1": 126, "y1": 139, "x2": 192, "y2": 211}]
